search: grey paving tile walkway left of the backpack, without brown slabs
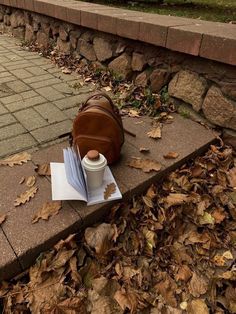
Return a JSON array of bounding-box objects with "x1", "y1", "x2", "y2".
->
[{"x1": 0, "y1": 35, "x2": 96, "y2": 157}]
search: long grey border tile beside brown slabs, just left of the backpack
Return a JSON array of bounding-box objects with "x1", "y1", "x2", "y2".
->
[{"x1": 30, "y1": 120, "x2": 72, "y2": 143}]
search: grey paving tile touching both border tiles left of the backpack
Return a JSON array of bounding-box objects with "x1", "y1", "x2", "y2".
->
[{"x1": 14, "y1": 108, "x2": 48, "y2": 131}]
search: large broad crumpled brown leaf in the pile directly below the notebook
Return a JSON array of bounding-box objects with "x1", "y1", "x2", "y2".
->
[{"x1": 84, "y1": 223, "x2": 116, "y2": 254}]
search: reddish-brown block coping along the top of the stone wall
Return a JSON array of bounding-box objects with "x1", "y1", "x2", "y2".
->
[{"x1": 0, "y1": 0, "x2": 236, "y2": 65}]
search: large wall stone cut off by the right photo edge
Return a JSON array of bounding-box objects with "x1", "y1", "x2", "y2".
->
[{"x1": 202, "y1": 86, "x2": 236, "y2": 130}]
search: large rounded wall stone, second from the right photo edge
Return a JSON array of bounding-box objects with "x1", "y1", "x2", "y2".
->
[{"x1": 168, "y1": 71, "x2": 207, "y2": 111}]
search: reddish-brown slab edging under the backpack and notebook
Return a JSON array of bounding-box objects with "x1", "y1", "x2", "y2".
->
[{"x1": 0, "y1": 114, "x2": 216, "y2": 279}]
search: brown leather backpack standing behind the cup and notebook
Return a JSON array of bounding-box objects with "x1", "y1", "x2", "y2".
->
[{"x1": 72, "y1": 93, "x2": 124, "y2": 164}]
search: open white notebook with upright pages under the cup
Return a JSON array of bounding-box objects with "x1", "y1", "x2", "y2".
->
[{"x1": 50, "y1": 147, "x2": 122, "y2": 205}]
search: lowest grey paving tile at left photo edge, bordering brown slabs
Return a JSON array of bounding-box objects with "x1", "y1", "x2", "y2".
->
[{"x1": 0, "y1": 134, "x2": 37, "y2": 157}]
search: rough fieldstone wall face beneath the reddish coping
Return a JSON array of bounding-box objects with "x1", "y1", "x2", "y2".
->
[{"x1": 0, "y1": 5, "x2": 236, "y2": 130}]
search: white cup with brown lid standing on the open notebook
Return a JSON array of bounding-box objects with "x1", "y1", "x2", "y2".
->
[{"x1": 82, "y1": 150, "x2": 107, "y2": 189}]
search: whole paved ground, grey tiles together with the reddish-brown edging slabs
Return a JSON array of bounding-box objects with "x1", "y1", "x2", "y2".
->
[{"x1": 0, "y1": 35, "x2": 218, "y2": 280}]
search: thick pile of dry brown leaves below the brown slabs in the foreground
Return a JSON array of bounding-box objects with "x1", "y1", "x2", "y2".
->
[{"x1": 0, "y1": 146, "x2": 236, "y2": 314}]
